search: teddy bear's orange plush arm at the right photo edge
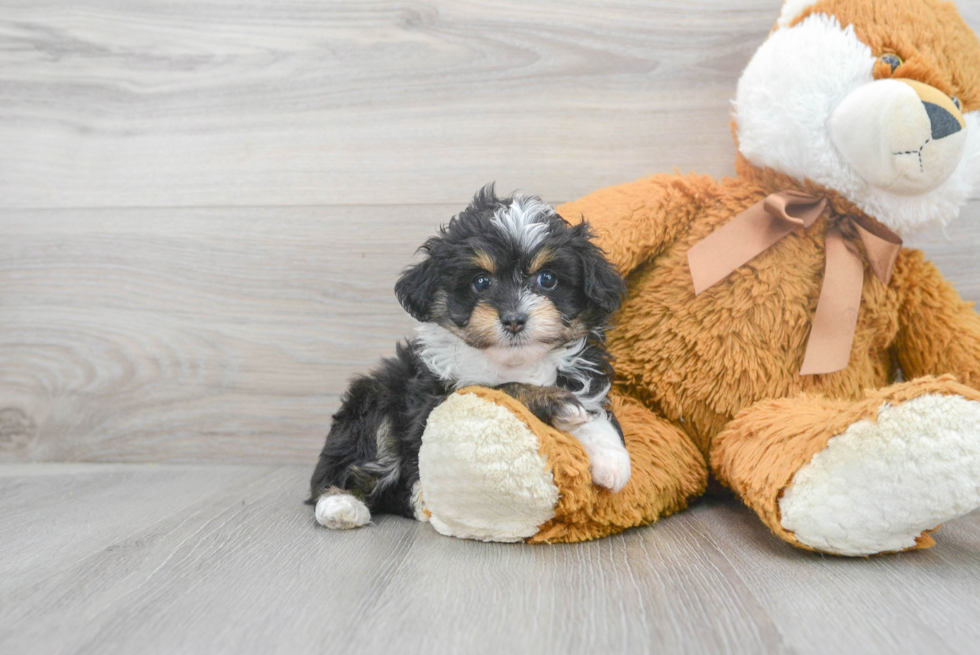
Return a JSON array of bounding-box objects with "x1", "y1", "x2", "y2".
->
[{"x1": 893, "y1": 250, "x2": 980, "y2": 389}]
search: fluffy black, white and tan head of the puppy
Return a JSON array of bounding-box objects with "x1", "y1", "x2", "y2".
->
[{"x1": 395, "y1": 185, "x2": 625, "y2": 349}]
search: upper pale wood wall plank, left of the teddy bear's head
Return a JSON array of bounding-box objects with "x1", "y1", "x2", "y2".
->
[{"x1": 0, "y1": 0, "x2": 780, "y2": 208}]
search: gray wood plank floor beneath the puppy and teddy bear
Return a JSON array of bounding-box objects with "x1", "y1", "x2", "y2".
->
[{"x1": 0, "y1": 464, "x2": 980, "y2": 655}]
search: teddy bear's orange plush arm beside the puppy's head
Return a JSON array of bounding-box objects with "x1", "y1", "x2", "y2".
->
[{"x1": 557, "y1": 175, "x2": 715, "y2": 275}]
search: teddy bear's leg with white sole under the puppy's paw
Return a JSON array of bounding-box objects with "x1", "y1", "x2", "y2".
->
[{"x1": 419, "y1": 387, "x2": 707, "y2": 542}]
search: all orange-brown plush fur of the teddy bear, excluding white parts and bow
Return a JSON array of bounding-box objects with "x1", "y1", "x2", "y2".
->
[{"x1": 436, "y1": 0, "x2": 980, "y2": 547}]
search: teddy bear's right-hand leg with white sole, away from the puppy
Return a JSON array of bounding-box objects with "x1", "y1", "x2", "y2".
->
[{"x1": 711, "y1": 377, "x2": 980, "y2": 556}]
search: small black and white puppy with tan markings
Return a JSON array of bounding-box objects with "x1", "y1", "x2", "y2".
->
[{"x1": 307, "y1": 185, "x2": 630, "y2": 529}]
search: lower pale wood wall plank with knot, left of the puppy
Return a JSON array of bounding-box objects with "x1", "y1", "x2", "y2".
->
[{"x1": 0, "y1": 207, "x2": 432, "y2": 462}]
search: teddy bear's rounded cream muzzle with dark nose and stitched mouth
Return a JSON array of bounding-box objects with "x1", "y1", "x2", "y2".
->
[{"x1": 828, "y1": 79, "x2": 967, "y2": 196}]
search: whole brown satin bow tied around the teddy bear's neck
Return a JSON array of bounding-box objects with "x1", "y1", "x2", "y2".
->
[{"x1": 687, "y1": 190, "x2": 902, "y2": 375}]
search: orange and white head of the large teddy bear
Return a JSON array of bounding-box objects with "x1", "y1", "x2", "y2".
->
[{"x1": 735, "y1": 0, "x2": 980, "y2": 233}]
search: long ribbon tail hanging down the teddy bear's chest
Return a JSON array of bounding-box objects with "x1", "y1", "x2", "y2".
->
[{"x1": 800, "y1": 228, "x2": 864, "y2": 375}]
